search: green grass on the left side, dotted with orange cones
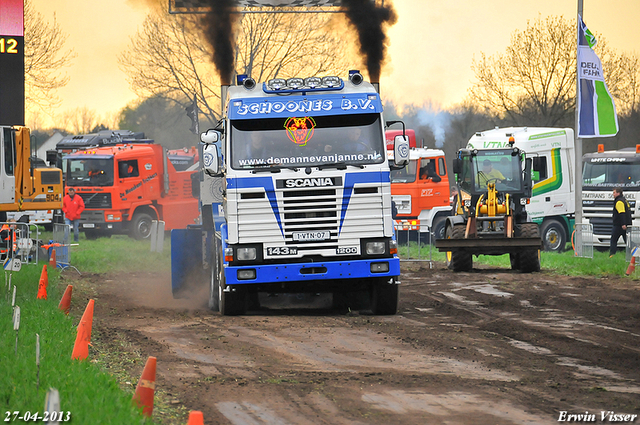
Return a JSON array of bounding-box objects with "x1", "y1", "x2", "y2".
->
[{"x1": 0, "y1": 235, "x2": 169, "y2": 425}]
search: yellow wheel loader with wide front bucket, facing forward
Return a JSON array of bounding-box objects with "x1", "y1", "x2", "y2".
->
[{"x1": 435, "y1": 145, "x2": 542, "y2": 273}]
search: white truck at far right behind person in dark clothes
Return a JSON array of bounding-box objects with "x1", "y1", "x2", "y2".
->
[{"x1": 582, "y1": 145, "x2": 640, "y2": 251}]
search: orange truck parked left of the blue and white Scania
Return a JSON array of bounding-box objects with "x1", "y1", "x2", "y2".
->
[{"x1": 64, "y1": 140, "x2": 199, "y2": 239}]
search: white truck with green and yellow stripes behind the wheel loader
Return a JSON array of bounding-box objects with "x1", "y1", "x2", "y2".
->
[{"x1": 467, "y1": 127, "x2": 576, "y2": 252}]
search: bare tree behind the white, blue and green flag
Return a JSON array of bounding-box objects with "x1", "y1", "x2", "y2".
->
[{"x1": 470, "y1": 16, "x2": 638, "y2": 126}]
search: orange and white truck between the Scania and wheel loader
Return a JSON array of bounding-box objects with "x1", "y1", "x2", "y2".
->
[{"x1": 385, "y1": 129, "x2": 451, "y2": 243}]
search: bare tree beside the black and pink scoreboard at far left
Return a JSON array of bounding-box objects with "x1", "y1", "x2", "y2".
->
[{"x1": 24, "y1": 0, "x2": 75, "y2": 113}]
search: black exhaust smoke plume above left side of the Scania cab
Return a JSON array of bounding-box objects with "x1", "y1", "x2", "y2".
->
[{"x1": 203, "y1": 0, "x2": 236, "y2": 85}]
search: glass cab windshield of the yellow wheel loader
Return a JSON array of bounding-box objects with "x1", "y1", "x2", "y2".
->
[{"x1": 461, "y1": 149, "x2": 522, "y2": 193}]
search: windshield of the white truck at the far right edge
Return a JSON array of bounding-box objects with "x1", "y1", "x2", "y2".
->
[{"x1": 582, "y1": 162, "x2": 640, "y2": 188}]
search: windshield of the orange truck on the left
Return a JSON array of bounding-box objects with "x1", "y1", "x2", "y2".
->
[{"x1": 65, "y1": 156, "x2": 113, "y2": 186}]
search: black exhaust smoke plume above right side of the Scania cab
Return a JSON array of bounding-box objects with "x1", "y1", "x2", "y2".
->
[{"x1": 342, "y1": 0, "x2": 397, "y2": 83}]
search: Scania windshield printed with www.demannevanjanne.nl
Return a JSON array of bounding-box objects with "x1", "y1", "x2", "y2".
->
[{"x1": 231, "y1": 114, "x2": 386, "y2": 169}]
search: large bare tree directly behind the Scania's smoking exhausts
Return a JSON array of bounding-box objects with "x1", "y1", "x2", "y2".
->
[{"x1": 119, "y1": 9, "x2": 347, "y2": 125}]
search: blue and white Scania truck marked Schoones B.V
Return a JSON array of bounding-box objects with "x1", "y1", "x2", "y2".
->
[{"x1": 171, "y1": 71, "x2": 409, "y2": 315}]
